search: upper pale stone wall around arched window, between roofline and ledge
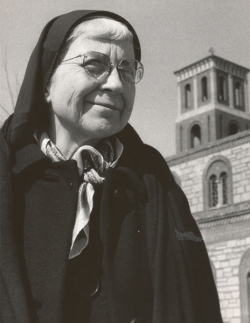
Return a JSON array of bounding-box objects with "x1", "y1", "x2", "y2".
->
[{"x1": 170, "y1": 135, "x2": 250, "y2": 213}]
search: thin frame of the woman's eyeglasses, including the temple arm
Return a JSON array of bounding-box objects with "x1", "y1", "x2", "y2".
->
[{"x1": 60, "y1": 51, "x2": 144, "y2": 84}]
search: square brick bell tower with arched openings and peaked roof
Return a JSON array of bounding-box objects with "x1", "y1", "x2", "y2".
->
[{"x1": 174, "y1": 49, "x2": 250, "y2": 154}]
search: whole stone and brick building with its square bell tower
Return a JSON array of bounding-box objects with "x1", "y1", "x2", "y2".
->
[{"x1": 167, "y1": 54, "x2": 250, "y2": 323}]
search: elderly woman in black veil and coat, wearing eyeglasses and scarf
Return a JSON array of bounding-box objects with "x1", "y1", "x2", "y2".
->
[{"x1": 0, "y1": 11, "x2": 222, "y2": 323}]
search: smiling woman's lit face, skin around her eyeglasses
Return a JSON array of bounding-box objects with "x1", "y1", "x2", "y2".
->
[{"x1": 46, "y1": 35, "x2": 135, "y2": 140}]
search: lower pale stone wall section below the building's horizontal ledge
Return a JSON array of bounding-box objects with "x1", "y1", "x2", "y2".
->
[{"x1": 205, "y1": 224, "x2": 250, "y2": 323}]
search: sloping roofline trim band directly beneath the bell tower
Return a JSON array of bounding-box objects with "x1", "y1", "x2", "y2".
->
[{"x1": 165, "y1": 130, "x2": 250, "y2": 167}]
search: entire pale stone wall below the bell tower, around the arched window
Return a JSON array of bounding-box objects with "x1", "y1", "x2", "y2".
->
[{"x1": 167, "y1": 131, "x2": 250, "y2": 323}]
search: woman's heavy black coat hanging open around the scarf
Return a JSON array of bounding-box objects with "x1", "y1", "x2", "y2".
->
[{"x1": 1, "y1": 126, "x2": 222, "y2": 323}]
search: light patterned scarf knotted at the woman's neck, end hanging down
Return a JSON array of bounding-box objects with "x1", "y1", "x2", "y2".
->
[{"x1": 40, "y1": 132, "x2": 123, "y2": 259}]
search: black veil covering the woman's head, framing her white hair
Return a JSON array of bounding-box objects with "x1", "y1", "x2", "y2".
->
[{"x1": 10, "y1": 10, "x2": 141, "y2": 147}]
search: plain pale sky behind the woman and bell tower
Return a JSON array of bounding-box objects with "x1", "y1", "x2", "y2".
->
[{"x1": 0, "y1": 0, "x2": 250, "y2": 157}]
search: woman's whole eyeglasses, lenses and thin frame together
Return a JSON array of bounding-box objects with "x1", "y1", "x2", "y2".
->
[{"x1": 62, "y1": 52, "x2": 144, "y2": 84}]
